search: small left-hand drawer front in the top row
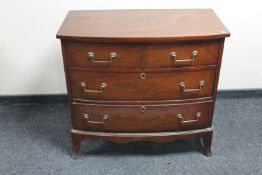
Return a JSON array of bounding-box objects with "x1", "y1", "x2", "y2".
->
[{"x1": 67, "y1": 44, "x2": 141, "y2": 68}]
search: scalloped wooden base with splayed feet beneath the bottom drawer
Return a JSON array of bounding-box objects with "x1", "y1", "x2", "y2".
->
[{"x1": 71, "y1": 128, "x2": 213, "y2": 159}]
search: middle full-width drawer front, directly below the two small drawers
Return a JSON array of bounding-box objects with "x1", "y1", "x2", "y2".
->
[{"x1": 70, "y1": 69, "x2": 215, "y2": 101}]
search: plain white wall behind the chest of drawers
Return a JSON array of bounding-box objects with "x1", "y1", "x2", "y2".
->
[{"x1": 0, "y1": 0, "x2": 262, "y2": 95}]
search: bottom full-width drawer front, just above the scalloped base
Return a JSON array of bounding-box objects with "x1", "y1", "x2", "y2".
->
[{"x1": 72, "y1": 101, "x2": 213, "y2": 132}]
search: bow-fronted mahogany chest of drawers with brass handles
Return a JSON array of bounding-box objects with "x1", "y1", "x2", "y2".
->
[{"x1": 57, "y1": 9, "x2": 230, "y2": 158}]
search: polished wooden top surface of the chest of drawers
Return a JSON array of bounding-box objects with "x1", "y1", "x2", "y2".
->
[{"x1": 57, "y1": 9, "x2": 230, "y2": 42}]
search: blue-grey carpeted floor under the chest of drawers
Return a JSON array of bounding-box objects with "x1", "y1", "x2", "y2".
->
[{"x1": 0, "y1": 98, "x2": 262, "y2": 175}]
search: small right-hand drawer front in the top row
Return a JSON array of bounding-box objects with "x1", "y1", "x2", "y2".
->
[{"x1": 145, "y1": 41, "x2": 219, "y2": 68}]
